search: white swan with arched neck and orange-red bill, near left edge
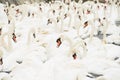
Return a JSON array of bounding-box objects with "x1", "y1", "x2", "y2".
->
[{"x1": 0, "y1": 30, "x2": 16, "y2": 69}]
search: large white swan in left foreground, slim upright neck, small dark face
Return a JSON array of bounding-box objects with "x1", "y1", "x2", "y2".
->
[{"x1": 3, "y1": 26, "x2": 46, "y2": 70}]
